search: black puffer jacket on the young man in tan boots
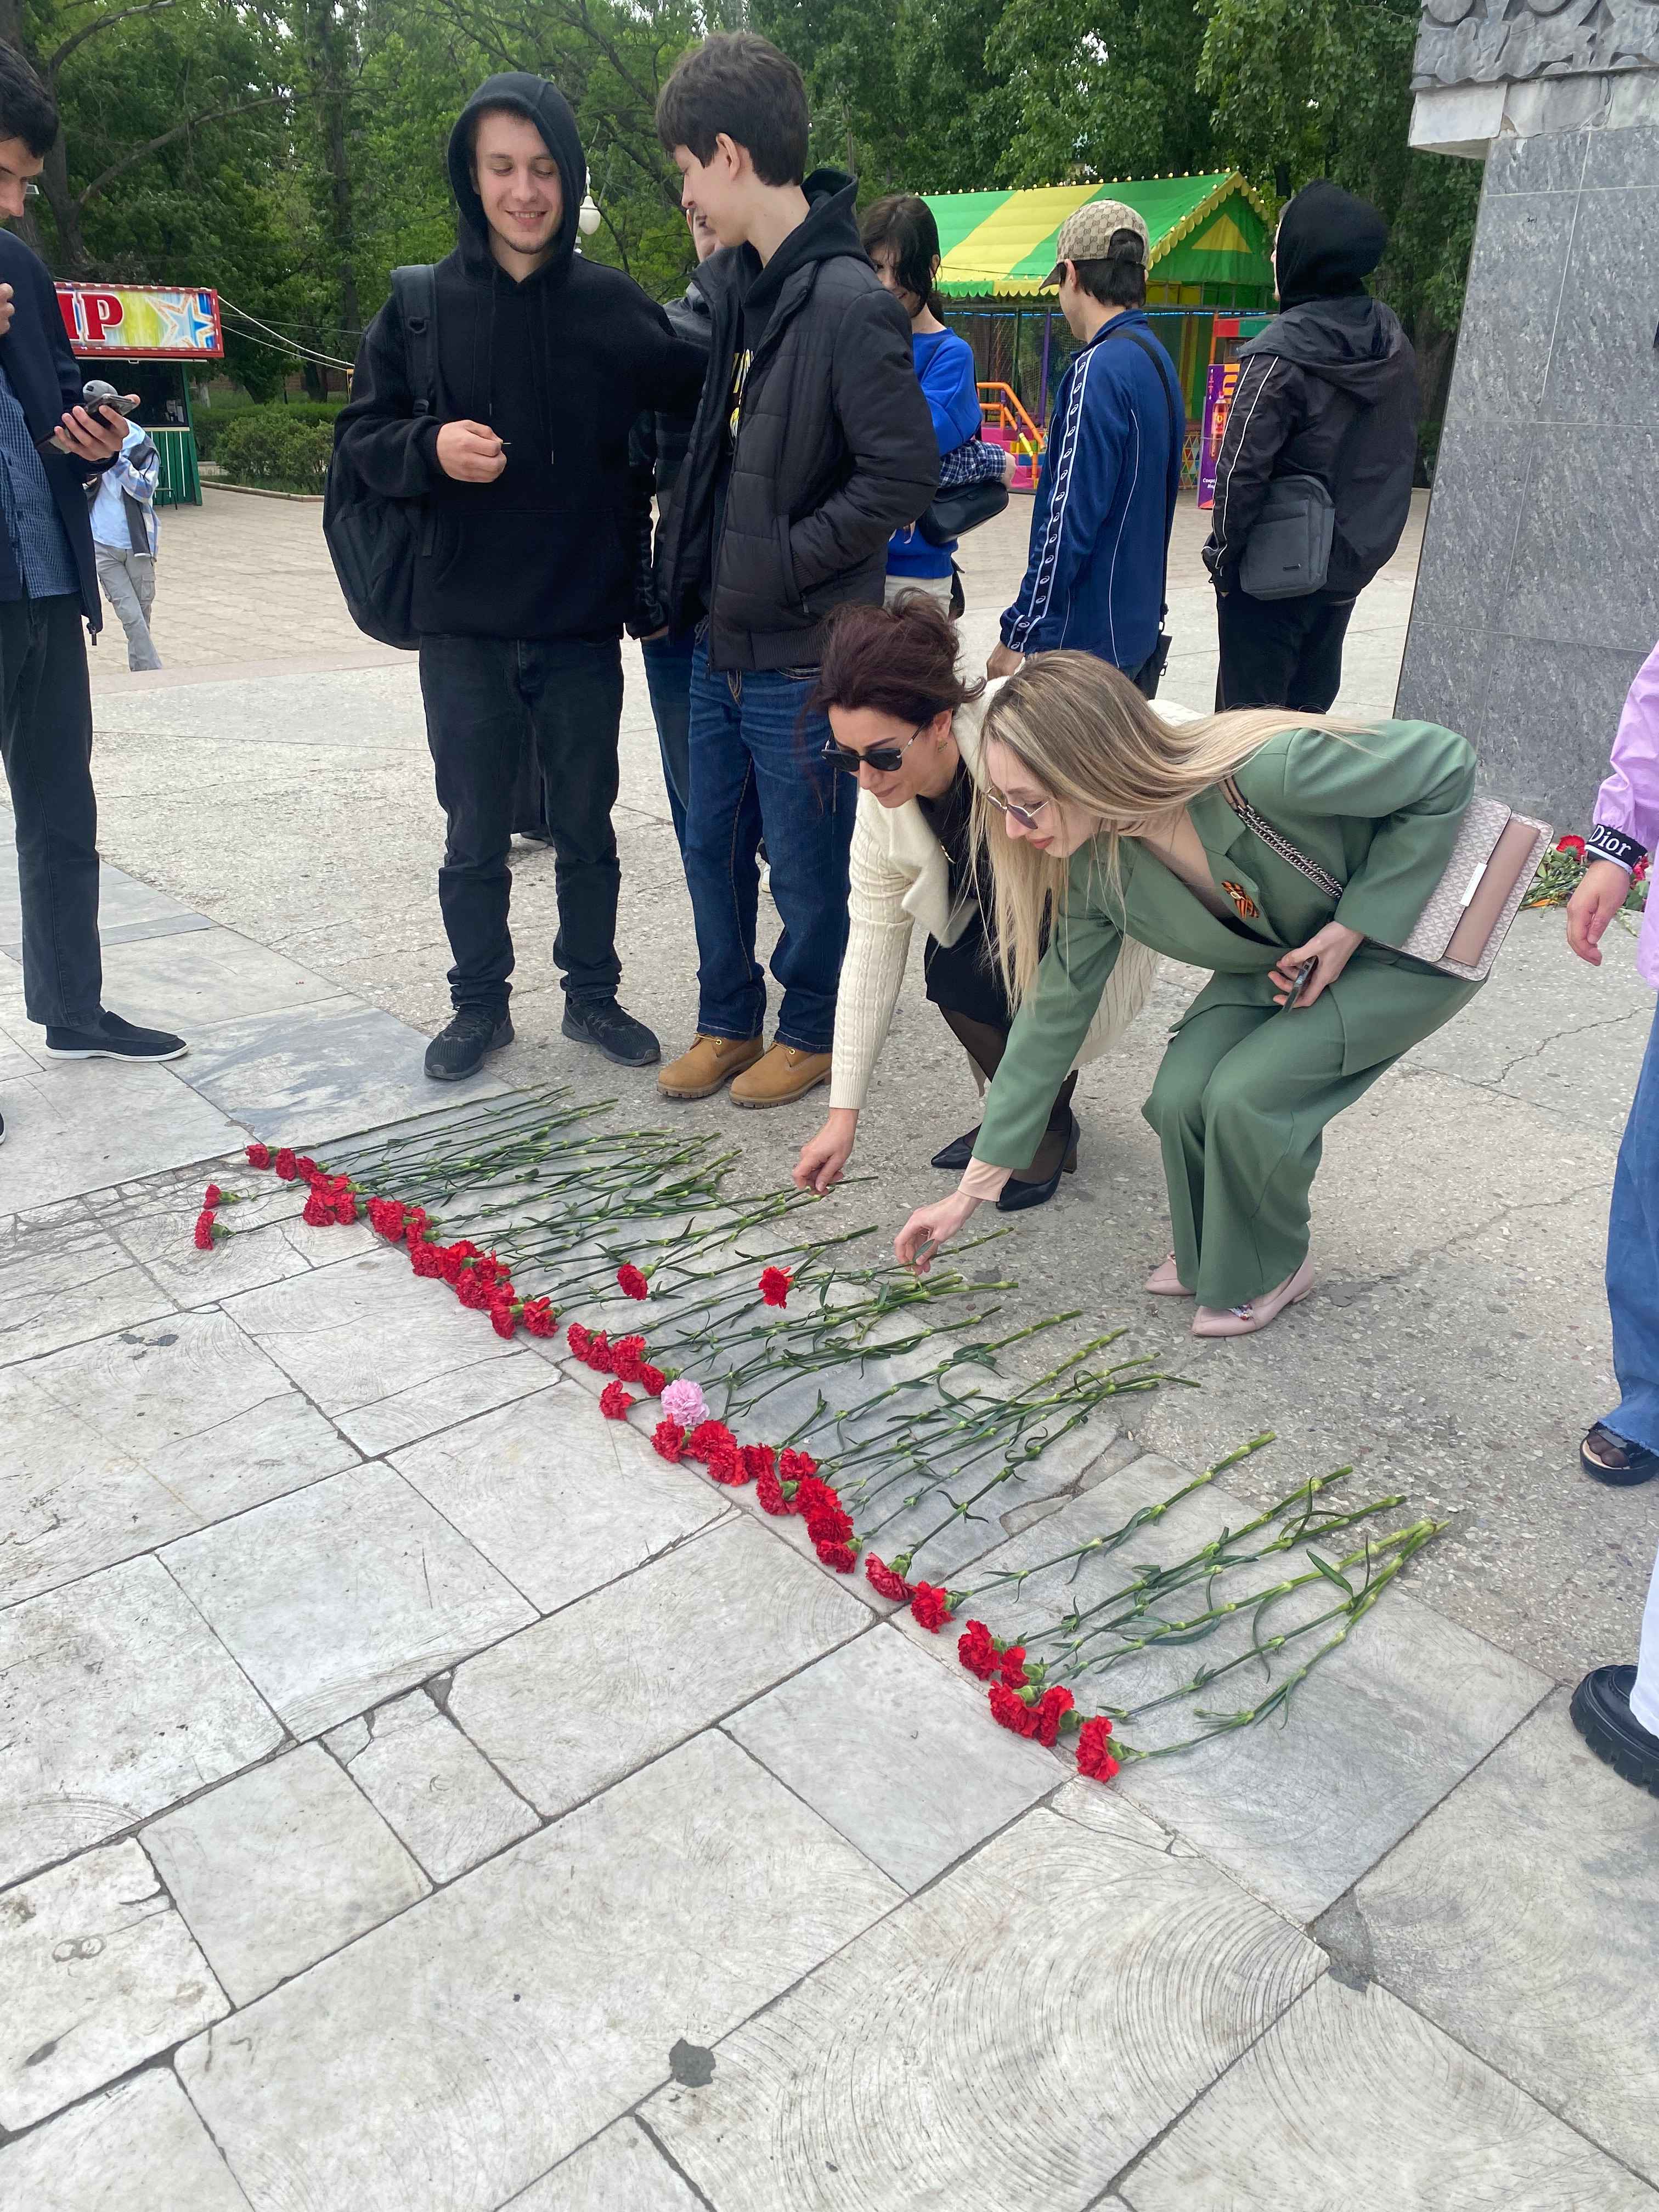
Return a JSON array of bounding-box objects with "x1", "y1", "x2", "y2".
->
[{"x1": 657, "y1": 168, "x2": 938, "y2": 670}]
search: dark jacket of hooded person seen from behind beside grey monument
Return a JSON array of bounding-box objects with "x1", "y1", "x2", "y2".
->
[{"x1": 1203, "y1": 292, "x2": 1418, "y2": 602}]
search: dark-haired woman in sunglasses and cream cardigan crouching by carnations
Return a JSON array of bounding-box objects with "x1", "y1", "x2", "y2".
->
[{"x1": 794, "y1": 593, "x2": 1157, "y2": 1212}]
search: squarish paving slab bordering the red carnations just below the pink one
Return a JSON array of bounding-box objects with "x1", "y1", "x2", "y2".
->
[{"x1": 392, "y1": 1363, "x2": 725, "y2": 1612}]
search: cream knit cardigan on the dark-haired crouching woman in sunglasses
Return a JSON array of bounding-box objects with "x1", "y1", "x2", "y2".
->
[{"x1": 830, "y1": 684, "x2": 1179, "y2": 1108}]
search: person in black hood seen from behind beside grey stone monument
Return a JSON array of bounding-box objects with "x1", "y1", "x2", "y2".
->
[{"x1": 1203, "y1": 177, "x2": 1418, "y2": 714}]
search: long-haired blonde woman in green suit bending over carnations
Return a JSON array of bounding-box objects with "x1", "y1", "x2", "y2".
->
[{"x1": 894, "y1": 652, "x2": 1477, "y2": 1336}]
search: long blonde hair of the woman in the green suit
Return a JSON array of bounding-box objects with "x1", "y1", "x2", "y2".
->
[{"x1": 973, "y1": 652, "x2": 1361, "y2": 1007}]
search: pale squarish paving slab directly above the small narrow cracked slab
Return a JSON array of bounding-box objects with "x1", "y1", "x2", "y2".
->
[{"x1": 163, "y1": 1460, "x2": 533, "y2": 1736}]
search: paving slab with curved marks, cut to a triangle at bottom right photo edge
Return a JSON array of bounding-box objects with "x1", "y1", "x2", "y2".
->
[{"x1": 1121, "y1": 1976, "x2": 1659, "y2": 2212}]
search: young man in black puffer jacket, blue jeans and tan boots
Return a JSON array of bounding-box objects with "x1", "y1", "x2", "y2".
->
[{"x1": 657, "y1": 47, "x2": 938, "y2": 1124}]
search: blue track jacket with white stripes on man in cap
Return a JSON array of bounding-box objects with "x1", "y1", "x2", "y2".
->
[{"x1": 1002, "y1": 307, "x2": 1186, "y2": 675}]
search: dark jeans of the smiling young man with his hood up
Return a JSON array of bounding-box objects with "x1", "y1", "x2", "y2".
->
[{"x1": 420, "y1": 637, "x2": 622, "y2": 1013}]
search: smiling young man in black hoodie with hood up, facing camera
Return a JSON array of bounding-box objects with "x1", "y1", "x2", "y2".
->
[{"x1": 336, "y1": 71, "x2": 703, "y2": 1082}]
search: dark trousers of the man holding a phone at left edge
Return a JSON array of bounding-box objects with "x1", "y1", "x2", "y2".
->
[{"x1": 0, "y1": 595, "x2": 104, "y2": 1029}]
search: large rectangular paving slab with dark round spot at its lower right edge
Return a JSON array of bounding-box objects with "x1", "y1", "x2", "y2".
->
[{"x1": 179, "y1": 1734, "x2": 900, "y2": 2212}]
